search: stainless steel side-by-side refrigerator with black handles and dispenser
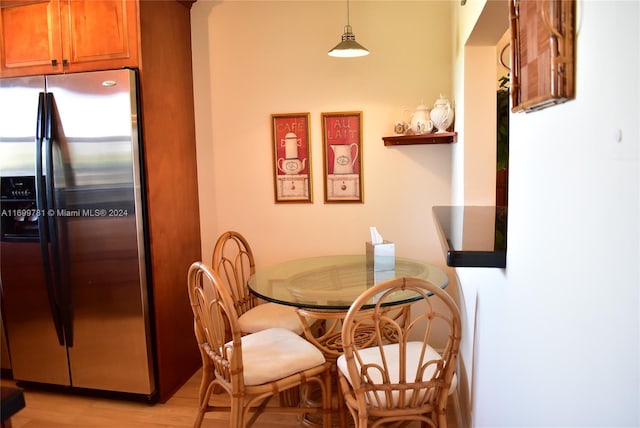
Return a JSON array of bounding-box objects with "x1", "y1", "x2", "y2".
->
[{"x1": 0, "y1": 69, "x2": 155, "y2": 400}]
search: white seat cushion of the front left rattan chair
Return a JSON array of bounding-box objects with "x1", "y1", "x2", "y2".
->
[{"x1": 227, "y1": 328, "x2": 325, "y2": 385}]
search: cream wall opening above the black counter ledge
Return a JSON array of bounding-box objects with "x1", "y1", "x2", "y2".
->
[{"x1": 450, "y1": 0, "x2": 509, "y2": 205}]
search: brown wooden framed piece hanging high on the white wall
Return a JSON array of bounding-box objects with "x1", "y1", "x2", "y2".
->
[{"x1": 509, "y1": 0, "x2": 576, "y2": 113}]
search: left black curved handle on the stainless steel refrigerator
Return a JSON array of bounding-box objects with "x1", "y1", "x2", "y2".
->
[{"x1": 35, "y1": 92, "x2": 65, "y2": 346}]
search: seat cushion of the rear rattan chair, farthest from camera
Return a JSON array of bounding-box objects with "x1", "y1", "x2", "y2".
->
[{"x1": 238, "y1": 302, "x2": 302, "y2": 335}]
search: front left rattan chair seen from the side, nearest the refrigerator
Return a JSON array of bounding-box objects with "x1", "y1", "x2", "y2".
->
[{"x1": 188, "y1": 262, "x2": 331, "y2": 428}]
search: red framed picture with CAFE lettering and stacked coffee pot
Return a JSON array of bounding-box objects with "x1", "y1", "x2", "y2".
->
[{"x1": 271, "y1": 113, "x2": 312, "y2": 203}]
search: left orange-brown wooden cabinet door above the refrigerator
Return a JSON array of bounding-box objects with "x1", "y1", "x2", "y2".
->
[{"x1": 0, "y1": 0, "x2": 62, "y2": 77}]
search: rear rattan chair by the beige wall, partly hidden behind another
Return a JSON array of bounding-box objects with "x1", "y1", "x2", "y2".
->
[{"x1": 211, "y1": 231, "x2": 303, "y2": 334}]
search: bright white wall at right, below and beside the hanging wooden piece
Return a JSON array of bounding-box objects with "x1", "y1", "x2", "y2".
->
[{"x1": 453, "y1": 0, "x2": 640, "y2": 427}]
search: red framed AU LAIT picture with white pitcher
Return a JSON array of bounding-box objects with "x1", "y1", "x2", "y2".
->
[{"x1": 322, "y1": 112, "x2": 363, "y2": 203}]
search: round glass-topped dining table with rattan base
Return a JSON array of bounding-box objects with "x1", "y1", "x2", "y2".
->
[{"x1": 248, "y1": 254, "x2": 449, "y2": 359}]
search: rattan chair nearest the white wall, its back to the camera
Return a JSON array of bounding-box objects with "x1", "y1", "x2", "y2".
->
[{"x1": 337, "y1": 278, "x2": 461, "y2": 428}]
